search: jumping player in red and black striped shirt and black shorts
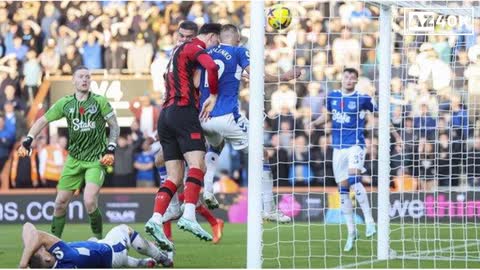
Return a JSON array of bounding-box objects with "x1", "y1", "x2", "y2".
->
[{"x1": 145, "y1": 23, "x2": 221, "y2": 250}]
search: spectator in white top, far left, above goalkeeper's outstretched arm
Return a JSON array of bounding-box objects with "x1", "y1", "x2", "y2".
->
[{"x1": 23, "y1": 50, "x2": 42, "y2": 104}]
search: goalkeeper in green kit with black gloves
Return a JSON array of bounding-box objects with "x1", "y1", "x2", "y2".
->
[{"x1": 18, "y1": 66, "x2": 120, "y2": 239}]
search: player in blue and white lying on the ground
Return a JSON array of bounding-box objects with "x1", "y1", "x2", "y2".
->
[{"x1": 19, "y1": 222, "x2": 173, "y2": 268}]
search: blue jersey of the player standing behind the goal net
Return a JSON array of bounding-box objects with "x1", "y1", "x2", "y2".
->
[{"x1": 327, "y1": 90, "x2": 377, "y2": 149}]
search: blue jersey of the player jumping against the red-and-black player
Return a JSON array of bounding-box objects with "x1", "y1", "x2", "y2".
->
[{"x1": 200, "y1": 44, "x2": 250, "y2": 118}]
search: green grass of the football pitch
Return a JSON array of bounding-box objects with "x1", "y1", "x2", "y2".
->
[{"x1": 0, "y1": 223, "x2": 480, "y2": 268}]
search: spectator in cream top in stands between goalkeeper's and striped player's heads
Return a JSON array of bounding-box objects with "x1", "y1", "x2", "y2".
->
[{"x1": 127, "y1": 34, "x2": 153, "y2": 74}]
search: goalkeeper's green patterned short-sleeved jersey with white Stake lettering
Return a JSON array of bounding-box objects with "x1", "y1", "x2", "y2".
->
[{"x1": 45, "y1": 92, "x2": 114, "y2": 161}]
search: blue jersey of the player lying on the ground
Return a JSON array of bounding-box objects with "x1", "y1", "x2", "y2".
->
[{"x1": 48, "y1": 241, "x2": 112, "y2": 268}]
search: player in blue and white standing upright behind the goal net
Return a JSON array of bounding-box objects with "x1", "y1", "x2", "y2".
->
[{"x1": 313, "y1": 68, "x2": 398, "y2": 251}]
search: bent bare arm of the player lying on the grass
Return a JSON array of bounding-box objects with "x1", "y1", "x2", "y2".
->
[{"x1": 18, "y1": 222, "x2": 61, "y2": 268}]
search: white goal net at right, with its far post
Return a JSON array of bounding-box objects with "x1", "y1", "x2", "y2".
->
[{"x1": 255, "y1": 1, "x2": 480, "y2": 268}]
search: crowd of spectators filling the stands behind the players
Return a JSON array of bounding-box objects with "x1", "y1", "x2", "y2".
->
[{"x1": 0, "y1": 1, "x2": 480, "y2": 190}]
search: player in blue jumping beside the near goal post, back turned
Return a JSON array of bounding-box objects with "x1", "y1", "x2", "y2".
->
[{"x1": 199, "y1": 24, "x2": 301, "y2": 223}]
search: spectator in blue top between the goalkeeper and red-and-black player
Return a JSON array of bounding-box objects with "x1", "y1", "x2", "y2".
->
[{"x1": 133, "y1": 139, "x2": 155, "y2": 187}]
